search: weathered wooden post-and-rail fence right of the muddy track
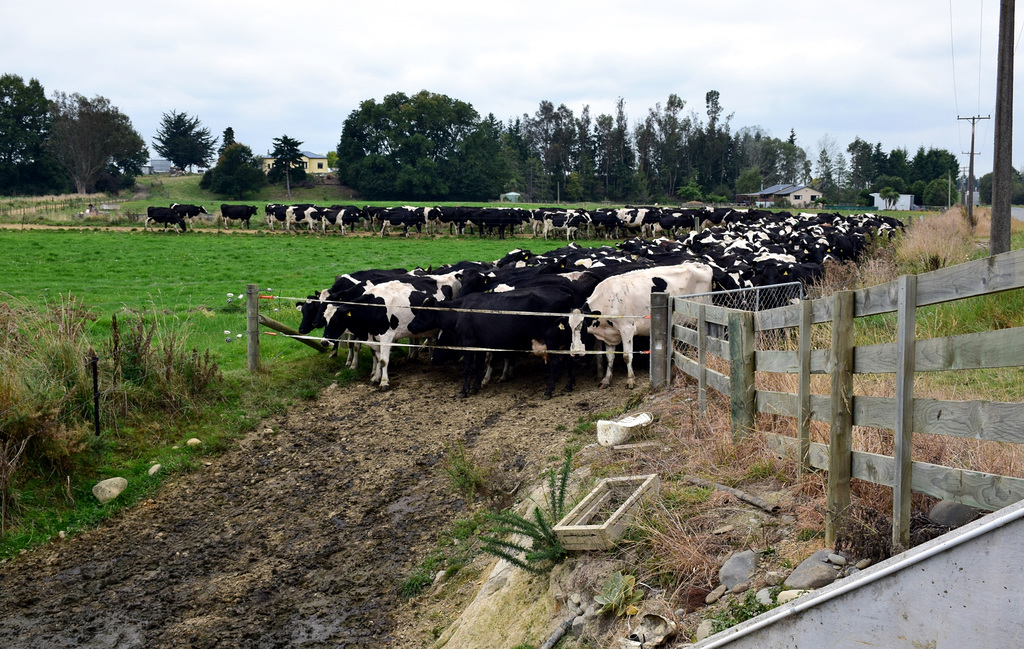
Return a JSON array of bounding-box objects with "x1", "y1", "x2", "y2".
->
[{"x1": 651, "y1": 250, "x2": 1024, "y2": 548}]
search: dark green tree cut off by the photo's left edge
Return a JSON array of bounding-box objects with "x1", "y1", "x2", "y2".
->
[{"x1": 0, "y1": 75, "x2": 68, "y2": 194}]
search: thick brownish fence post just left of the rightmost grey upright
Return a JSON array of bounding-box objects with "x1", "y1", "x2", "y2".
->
[{"x1": 825, "y1": 291, "x2": 854, "y2": 548}]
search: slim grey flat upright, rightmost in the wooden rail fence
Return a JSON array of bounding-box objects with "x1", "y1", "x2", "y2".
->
[{"x1": 893, "y1": 275, "x2": 918, "y2": 548}]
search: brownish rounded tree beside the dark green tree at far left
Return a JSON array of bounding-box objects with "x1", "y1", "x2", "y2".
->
[{"x1": 46, "y1": 92, "x2": 148, "y2": 193}]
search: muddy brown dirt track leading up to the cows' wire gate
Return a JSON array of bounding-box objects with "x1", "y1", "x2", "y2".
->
[{"x1": 0, "y1": 361, "x2": 642, "y2": 649}]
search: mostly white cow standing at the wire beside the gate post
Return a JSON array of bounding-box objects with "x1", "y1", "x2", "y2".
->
[{"x1": 569, "y1": 262, "x2": 712, "y2": 388}]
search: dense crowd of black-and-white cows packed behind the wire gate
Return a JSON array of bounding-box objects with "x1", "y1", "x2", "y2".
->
[{"x1": 297, "y1": 210, "x2": 903, "y2": 398}]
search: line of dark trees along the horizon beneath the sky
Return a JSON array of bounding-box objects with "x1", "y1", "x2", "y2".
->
[{"x1": 0, "y1": 74, "x2": 959, "y2": 205}]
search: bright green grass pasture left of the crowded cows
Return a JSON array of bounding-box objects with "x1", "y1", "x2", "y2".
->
[{"x1": 0, "y1": 228, "x2": 606, "y2": 372}]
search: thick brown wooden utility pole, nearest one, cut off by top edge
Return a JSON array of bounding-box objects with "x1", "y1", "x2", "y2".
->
[{"x1": 988, "y1": 0, "x2": 1014, "y2": 255}]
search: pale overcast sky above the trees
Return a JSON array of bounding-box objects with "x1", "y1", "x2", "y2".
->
[{"x1": 0, "y1": 0, "x2": 1024, "y2": 176}]
